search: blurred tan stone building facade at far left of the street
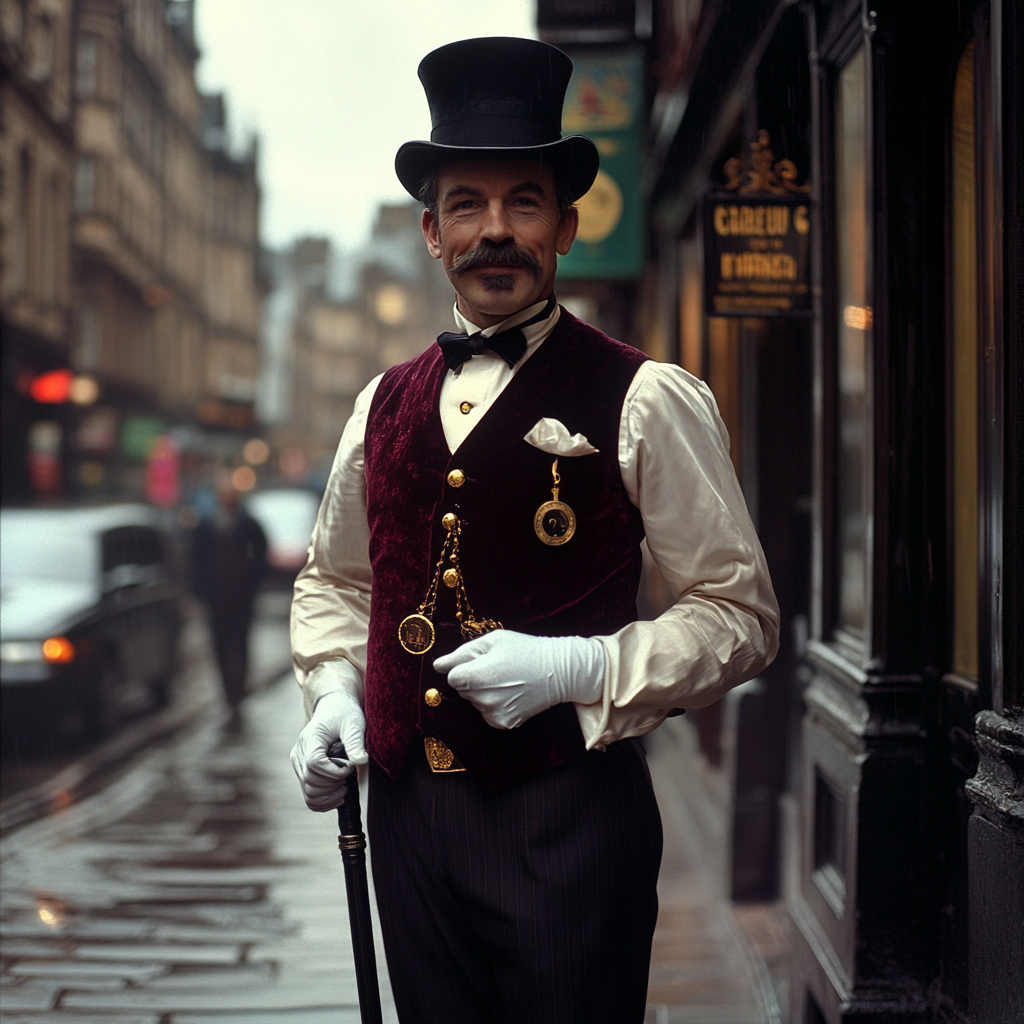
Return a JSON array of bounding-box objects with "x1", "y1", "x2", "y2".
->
[{"x1": 0, "y1": 0, "x2": 264, "y2": 499}]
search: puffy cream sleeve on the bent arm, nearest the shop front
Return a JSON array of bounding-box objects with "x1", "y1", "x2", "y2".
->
[{"x1": 577, "y1": 361, "x2": 779, "y2": 749}]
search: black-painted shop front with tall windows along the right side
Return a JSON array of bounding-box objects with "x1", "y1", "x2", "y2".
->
[{"x1": 634, "y1": 0, "x2": 1024, "y2": 1024}]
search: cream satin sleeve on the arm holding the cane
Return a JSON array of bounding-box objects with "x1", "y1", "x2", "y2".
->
[{"x1": 291, "y1": 377, "x2": 380, "y2": 717}]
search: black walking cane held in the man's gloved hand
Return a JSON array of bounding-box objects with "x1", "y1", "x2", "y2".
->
[{"x1": 327, "y1": 740, "x2": 382, "y2": 1024}]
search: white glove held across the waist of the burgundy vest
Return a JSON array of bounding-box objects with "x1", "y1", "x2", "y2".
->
[{"x1": 434, "y1": 630, "x2": 608, "y2": 729}]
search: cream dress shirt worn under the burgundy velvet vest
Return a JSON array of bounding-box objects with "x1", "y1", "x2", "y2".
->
[{"x1": 292, "y1": 302, "x2": 778, "y2": 749}]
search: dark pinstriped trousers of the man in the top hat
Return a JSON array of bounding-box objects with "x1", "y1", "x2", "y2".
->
[{"x1": 367, "y1": 740, "x2": 662, "y2": 1024}]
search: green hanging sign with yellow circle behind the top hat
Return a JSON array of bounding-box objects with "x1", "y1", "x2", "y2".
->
[{"x1": 558, "y1": 49, "x2": 644, "y2": 280}]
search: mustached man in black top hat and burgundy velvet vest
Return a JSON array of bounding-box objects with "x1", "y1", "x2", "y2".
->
[{"x1": 292, "y1": 39, "x2": 778, "y2": 1024}]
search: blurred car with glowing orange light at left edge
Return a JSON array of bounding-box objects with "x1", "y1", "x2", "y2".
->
[{"x1": 0, "y1": 504, "x2": 181, "y2": 748}]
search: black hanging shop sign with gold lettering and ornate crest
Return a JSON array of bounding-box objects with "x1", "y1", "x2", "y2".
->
[{"x1": 703, "y1": 131, "x2": 812, "y2": 316}]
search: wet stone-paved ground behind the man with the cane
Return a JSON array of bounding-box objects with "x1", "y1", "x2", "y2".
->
[{"x1": 0, "y1": 602, "x2": 780, "y2": 1024}]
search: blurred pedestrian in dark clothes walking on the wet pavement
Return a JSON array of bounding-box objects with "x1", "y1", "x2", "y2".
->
[{"x1": 191, "y1": 475, "x2": 266, "y2": 728}]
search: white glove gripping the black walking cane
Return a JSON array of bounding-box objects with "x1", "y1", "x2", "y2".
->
[{"x1": 292, "y1": 690, "x2": 370, "y2": 811}]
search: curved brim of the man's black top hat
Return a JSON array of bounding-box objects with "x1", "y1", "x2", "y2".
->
[{"x1": 394, "y1": 135, "x2": 601, "y2": 203}]
